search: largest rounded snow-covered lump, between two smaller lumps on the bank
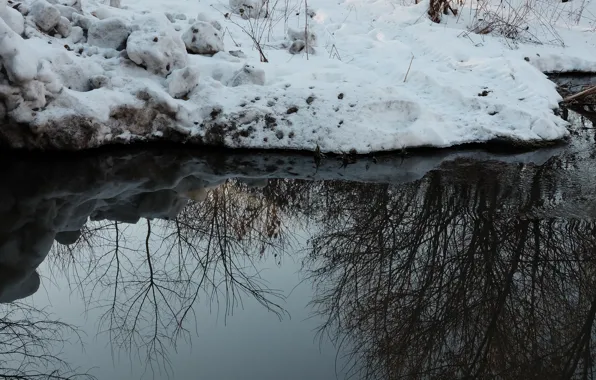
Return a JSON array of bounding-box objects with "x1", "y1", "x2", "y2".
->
[{"x1": 126, "y1": 15, "x2": 187, "y2": 76}]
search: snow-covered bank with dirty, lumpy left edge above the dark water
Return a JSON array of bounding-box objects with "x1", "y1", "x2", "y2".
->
[{"x1": 0, "y1": 0, "x2": 596, "y2": 153}]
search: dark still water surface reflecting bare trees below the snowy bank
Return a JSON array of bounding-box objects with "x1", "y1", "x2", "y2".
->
[{"x1": 0, "y1": 113, "x2": 596, "y2": 380}]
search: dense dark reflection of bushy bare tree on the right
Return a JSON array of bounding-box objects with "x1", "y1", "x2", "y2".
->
[{"x1": 308, "y1": 162, "x2": 596, "y2": 379}]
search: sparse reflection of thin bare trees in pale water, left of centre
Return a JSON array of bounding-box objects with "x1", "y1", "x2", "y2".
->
[{"x1": 49, "y1": 180, "x2": 310, "y2": 374}]
